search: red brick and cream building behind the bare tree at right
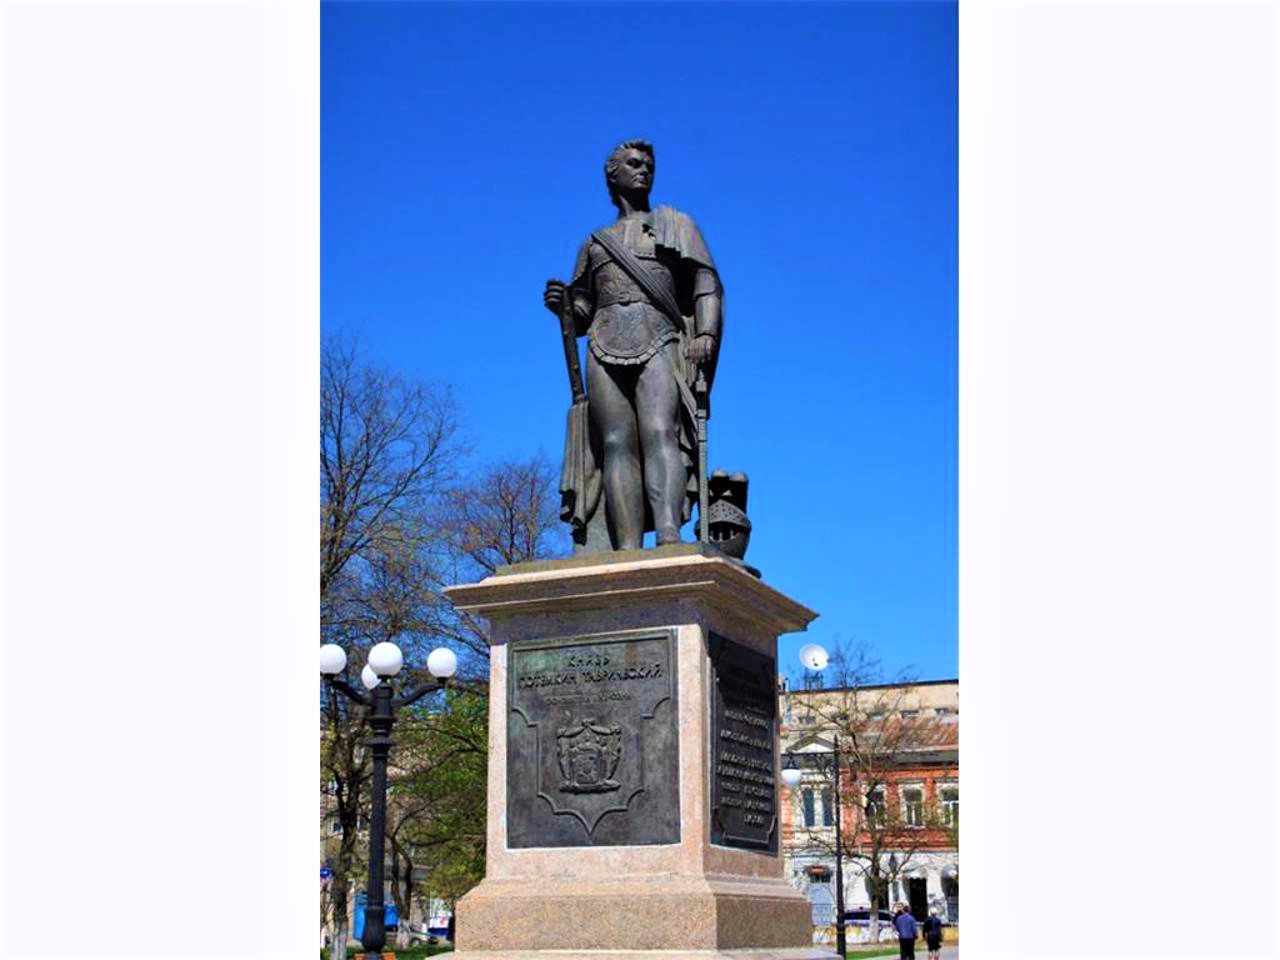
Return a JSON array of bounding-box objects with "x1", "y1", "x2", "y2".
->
[{"x1": 778, "y1": 680, "x2": 960, "y2": 942}]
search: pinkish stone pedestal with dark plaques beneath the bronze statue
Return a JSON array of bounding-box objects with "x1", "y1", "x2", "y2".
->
[{"x1": 448, "y1": 544, "x2": 835, "y2": 960}]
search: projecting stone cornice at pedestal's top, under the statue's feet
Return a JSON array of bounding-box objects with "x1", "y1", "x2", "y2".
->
[{"x1": 444, "y1": 544, "x2": 818, "y2": 635}]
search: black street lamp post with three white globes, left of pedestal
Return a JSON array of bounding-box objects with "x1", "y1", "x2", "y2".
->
[{"x1": 320, "y1": 641, "x2": 458, "y2": 954}]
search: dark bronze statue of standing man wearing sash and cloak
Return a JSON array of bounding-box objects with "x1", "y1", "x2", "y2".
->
[{"x1": 543, "y1": 140, "x2": 723, "y2": 549}]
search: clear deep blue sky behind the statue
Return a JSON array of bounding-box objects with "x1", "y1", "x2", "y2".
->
[{"x1": 320, "y1": 3, "x2": 957, "y2": 678}]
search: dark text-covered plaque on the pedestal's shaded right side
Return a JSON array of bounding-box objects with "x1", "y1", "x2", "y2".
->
[{"x1": 709, "y1": 634, "x2": 778, "y2": 854}]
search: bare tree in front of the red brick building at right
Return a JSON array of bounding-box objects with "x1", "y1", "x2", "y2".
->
[{"x1": 791, "y1": 644, "x2": 954, "y2": 942}]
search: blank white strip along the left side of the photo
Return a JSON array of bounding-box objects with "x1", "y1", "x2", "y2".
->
[{"x1": 0, "y1": 3, "x2": 320, "y2": 957}]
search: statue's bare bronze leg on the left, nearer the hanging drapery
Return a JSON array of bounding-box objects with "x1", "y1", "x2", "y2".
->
[{"x1": 586, "y1": 351, "x2": 644, "y2": 550}]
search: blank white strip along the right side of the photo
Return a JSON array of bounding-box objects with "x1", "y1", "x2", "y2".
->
[{"x1": 959, "y1": 0, "x2": 1280, "y2": 960}]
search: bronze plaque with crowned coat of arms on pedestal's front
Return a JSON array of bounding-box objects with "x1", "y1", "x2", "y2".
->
[{"x1": 507, "y1": 630, "x2": 680, "y2": 847}]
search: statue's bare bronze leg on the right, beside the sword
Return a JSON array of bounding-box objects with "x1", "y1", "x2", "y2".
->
[{"x1": 636, "y1": 343, "x2": 685, "y2": 544}]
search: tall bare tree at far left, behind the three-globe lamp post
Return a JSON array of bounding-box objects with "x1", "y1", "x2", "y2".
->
[{"x1": 320, "y1": 338, "x2": 461, "y2": 960}]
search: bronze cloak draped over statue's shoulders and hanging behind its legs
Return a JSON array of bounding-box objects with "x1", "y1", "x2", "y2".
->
[{"x1": 559, "y1": 206, "x2": 723, "y2": 548}]
